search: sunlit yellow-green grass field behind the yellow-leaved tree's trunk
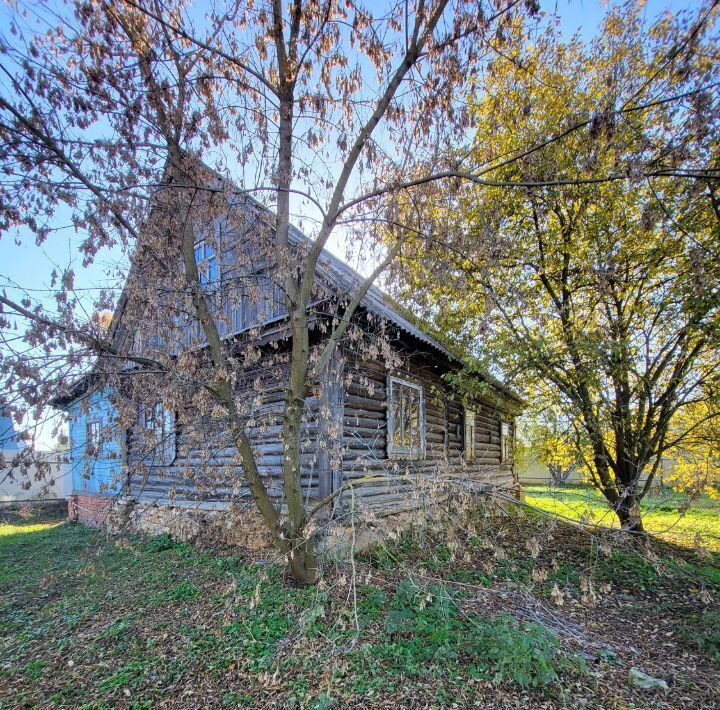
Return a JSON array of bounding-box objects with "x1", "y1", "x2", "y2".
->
[{"x1": 524, "y1": 485, "x2": 720, "y2": 552}]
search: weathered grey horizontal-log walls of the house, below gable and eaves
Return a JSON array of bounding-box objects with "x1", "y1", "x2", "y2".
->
[{"x1": 127, "y1": 340, "x2": 513, "y2": 515}]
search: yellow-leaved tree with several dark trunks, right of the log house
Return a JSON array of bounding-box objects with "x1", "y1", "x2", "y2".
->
[{"x1": 388, "y1": 3, "x2": 720, "y2": 532}]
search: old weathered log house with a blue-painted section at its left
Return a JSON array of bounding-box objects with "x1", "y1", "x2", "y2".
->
[{"x1": 55, "y1": 170, "x2": 523, "y2": 544}]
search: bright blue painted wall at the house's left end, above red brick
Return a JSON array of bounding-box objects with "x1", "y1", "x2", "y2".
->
[{"x1": 67, "y1": 391, "x2": 123, "y2": 495}]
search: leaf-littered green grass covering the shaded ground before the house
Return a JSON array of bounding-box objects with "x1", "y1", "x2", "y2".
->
[{"x1": 5, "y1": 498, "x2": 720, "y2": 708}]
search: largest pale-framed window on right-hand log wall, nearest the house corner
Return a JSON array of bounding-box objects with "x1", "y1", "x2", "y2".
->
[{"x1": 387, "y1": 377, "x2": 425, "y2": 459}]
